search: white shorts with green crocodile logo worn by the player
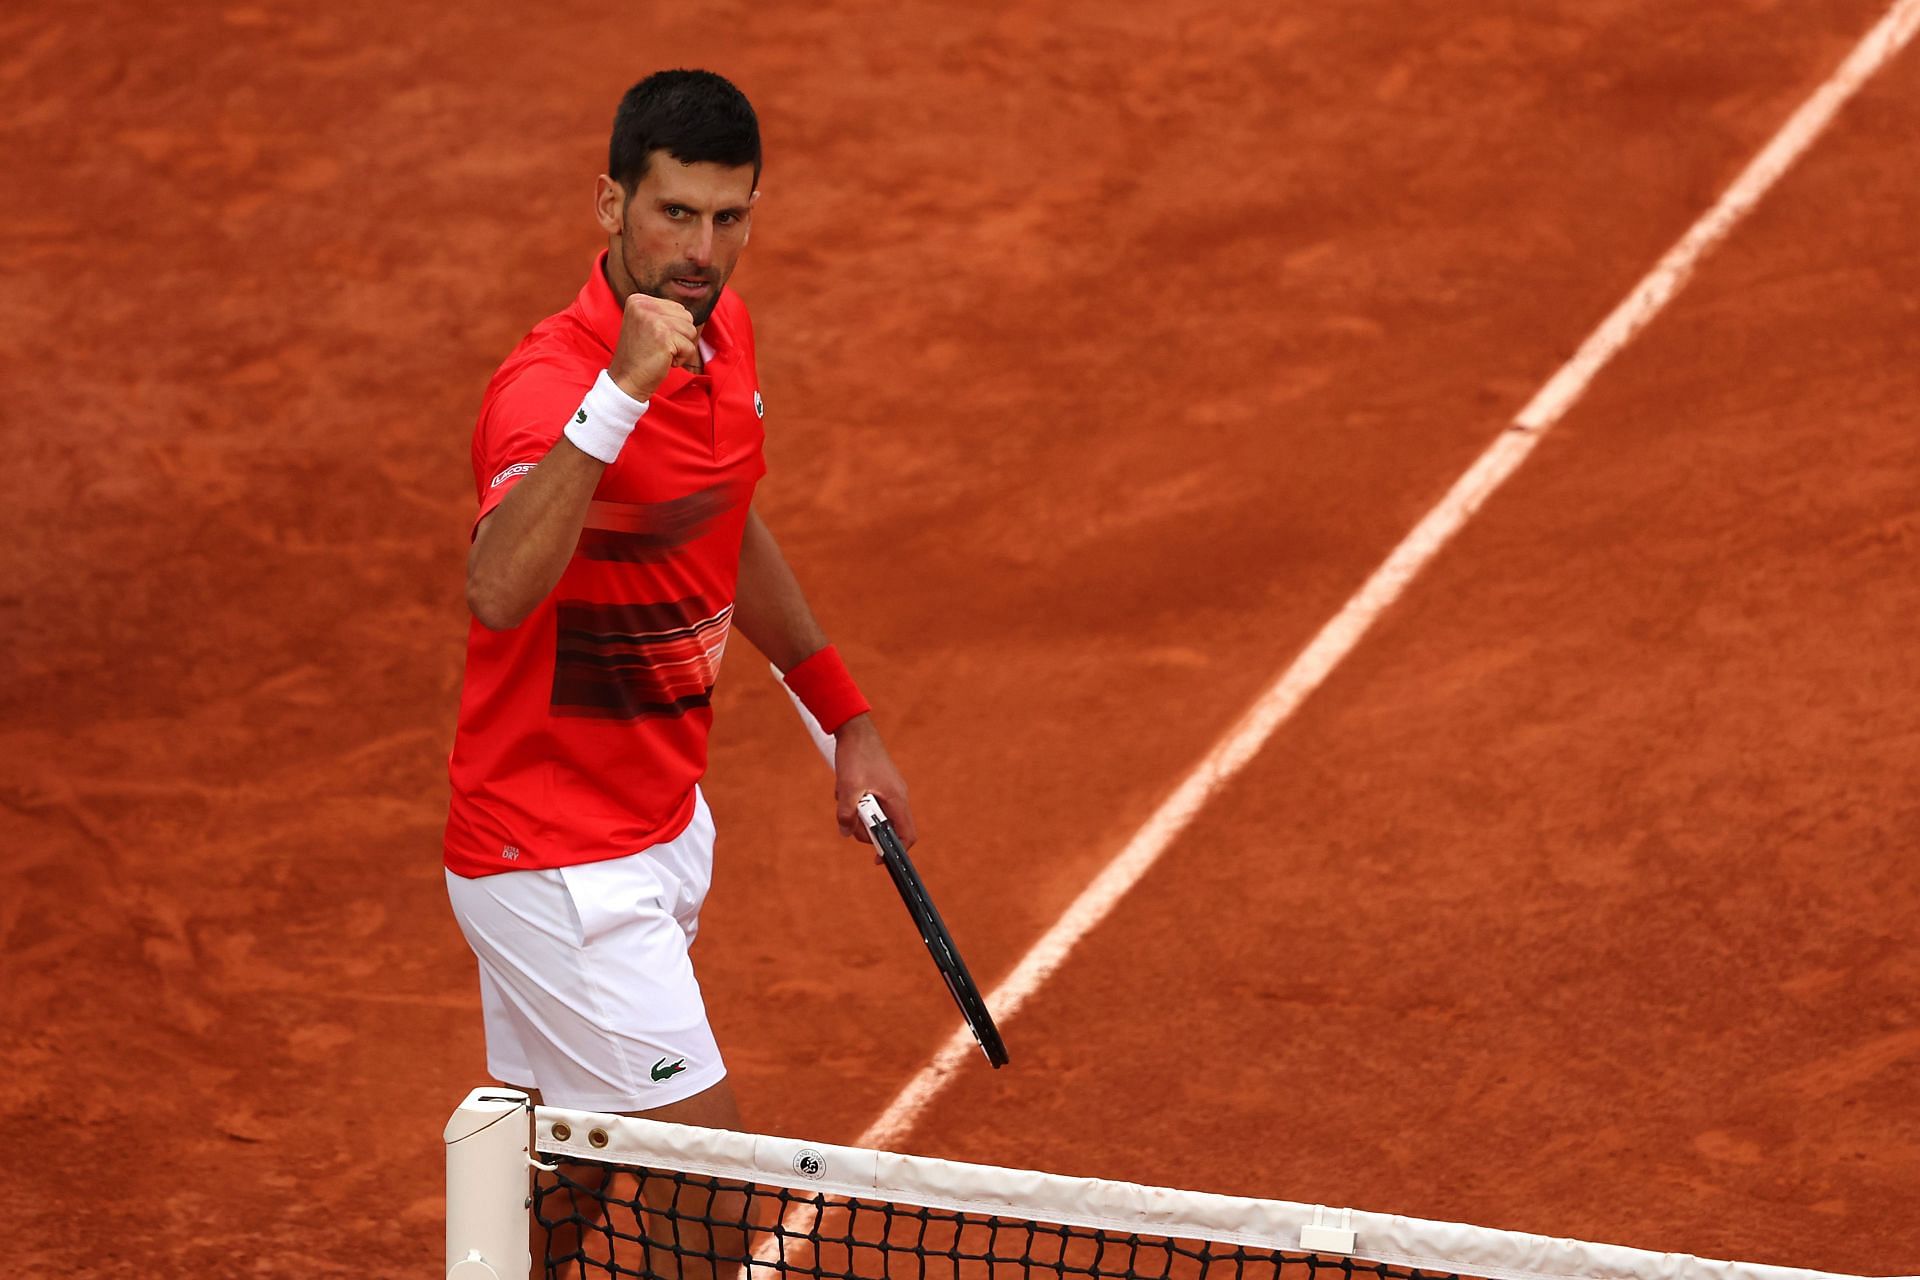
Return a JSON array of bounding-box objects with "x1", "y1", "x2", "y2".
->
[{"x1": 447, "y1": 789, "x2": 726, "y2": 1111}]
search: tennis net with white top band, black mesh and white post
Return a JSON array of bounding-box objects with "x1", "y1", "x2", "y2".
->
[{"x1": 447, "y1": 1090, "x2": 1914, "y2": 1280}]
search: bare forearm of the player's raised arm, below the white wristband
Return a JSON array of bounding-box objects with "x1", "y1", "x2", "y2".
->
[{"x1": 467, "y1": 438, "x2": 607, "y2": 631}]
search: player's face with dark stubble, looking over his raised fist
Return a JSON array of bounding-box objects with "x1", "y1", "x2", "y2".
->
[{"x1": 593, "y1": 152, "x2": 760, "y2": 324}]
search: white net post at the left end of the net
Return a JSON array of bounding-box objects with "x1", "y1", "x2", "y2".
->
[{"x1": 444, "y1": 1088, "x2": 534, "y2": 1280}]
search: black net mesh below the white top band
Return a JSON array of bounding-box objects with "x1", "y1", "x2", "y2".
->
[{"x1": 534, "y1": 1157, "x2": 1474, "y2": 1280}]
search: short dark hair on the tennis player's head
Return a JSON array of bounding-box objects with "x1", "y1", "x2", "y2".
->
[{"x1": 607, "y1": 71, "x2": 760, "y2": 190}]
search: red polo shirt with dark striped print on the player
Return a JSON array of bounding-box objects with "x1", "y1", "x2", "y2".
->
[{"x1": 445, "y1": 253, "x2": 766, "y2": 875}]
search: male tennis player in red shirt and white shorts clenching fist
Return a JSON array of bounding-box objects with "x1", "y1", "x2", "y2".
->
[{"x1": 445, "y1": 71, "x2": 914, "y2": 1128}]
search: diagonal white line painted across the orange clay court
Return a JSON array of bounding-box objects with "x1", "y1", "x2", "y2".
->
[{"x1": 854, "y1": 0, "x2": 1920, "y2": 1148}]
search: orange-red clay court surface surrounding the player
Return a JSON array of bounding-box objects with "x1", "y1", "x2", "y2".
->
[{"x1": 0, "y1": 0, "x2": 1920, "y2": 1280}]
